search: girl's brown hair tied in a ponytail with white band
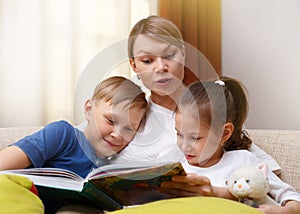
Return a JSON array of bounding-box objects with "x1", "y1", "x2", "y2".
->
[{"x1": 178, "y1": 77, "x2": 252, "y2": 151}]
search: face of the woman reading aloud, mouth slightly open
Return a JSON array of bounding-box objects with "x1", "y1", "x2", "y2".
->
[{"x1": 130, "y1": 35, "x2": 184, "y2": 96}]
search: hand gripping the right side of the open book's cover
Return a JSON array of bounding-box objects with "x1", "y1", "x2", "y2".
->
[{"x1": 160, "y1": 174, "x2": 215, "y2": 197}]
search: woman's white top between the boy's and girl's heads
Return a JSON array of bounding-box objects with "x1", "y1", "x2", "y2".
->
[{"x1": 111, "y1": 100, "x2": 184, "y2": 163}]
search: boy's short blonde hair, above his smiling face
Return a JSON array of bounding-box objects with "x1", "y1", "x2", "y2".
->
[{"x1": 92, "y1": 76, "x2": 148, "y2": 110}]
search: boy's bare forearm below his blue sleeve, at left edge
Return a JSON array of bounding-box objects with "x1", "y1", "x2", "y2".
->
[{"x1": 0, "y1": 146, "x2": 31, "y2": 170}]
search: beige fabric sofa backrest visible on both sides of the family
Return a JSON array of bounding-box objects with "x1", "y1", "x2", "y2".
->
[{"x1": 0, "y1": 127, "x2": 300, "y2": 211}]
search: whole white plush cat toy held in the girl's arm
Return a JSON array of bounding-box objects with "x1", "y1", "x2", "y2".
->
[{"x1": 227, "y1": 163, "x2": 276, "y2": 207}]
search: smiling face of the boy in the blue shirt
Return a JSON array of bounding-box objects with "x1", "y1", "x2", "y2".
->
[{"x1": 84, "y1": 100, "x2": 145, "y2": 158}]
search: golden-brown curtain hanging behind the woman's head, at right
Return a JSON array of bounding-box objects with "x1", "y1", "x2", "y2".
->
[{"x1": 159, "y1": 0, "x2": 221, "y2": 84}]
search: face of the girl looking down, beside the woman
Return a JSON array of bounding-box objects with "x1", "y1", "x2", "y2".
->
[{"x1": 175, "y1": 108, "x2": 223, "y2": 167}]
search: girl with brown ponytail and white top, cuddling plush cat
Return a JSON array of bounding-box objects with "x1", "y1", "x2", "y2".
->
[{"x1": 162, "y1": 77, "x2": 300, "y2": 213}]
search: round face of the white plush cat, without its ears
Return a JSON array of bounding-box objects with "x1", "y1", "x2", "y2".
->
[{"x1": 227, "y1": 165, "x2": 269, "y2": 199}]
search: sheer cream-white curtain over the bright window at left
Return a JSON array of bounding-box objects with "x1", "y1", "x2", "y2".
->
[{"x1": 0, "y1": 0, "x2": 157, "y2": 127}]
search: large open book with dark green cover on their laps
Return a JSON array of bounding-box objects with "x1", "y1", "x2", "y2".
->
[{"x1": 0, "y1": 163, "x2": 186, "y2": 211}]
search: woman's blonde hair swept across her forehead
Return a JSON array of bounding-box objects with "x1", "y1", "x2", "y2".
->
[{"x1": 127, "y1": 16, "x2": 184, "y2": 59}]
